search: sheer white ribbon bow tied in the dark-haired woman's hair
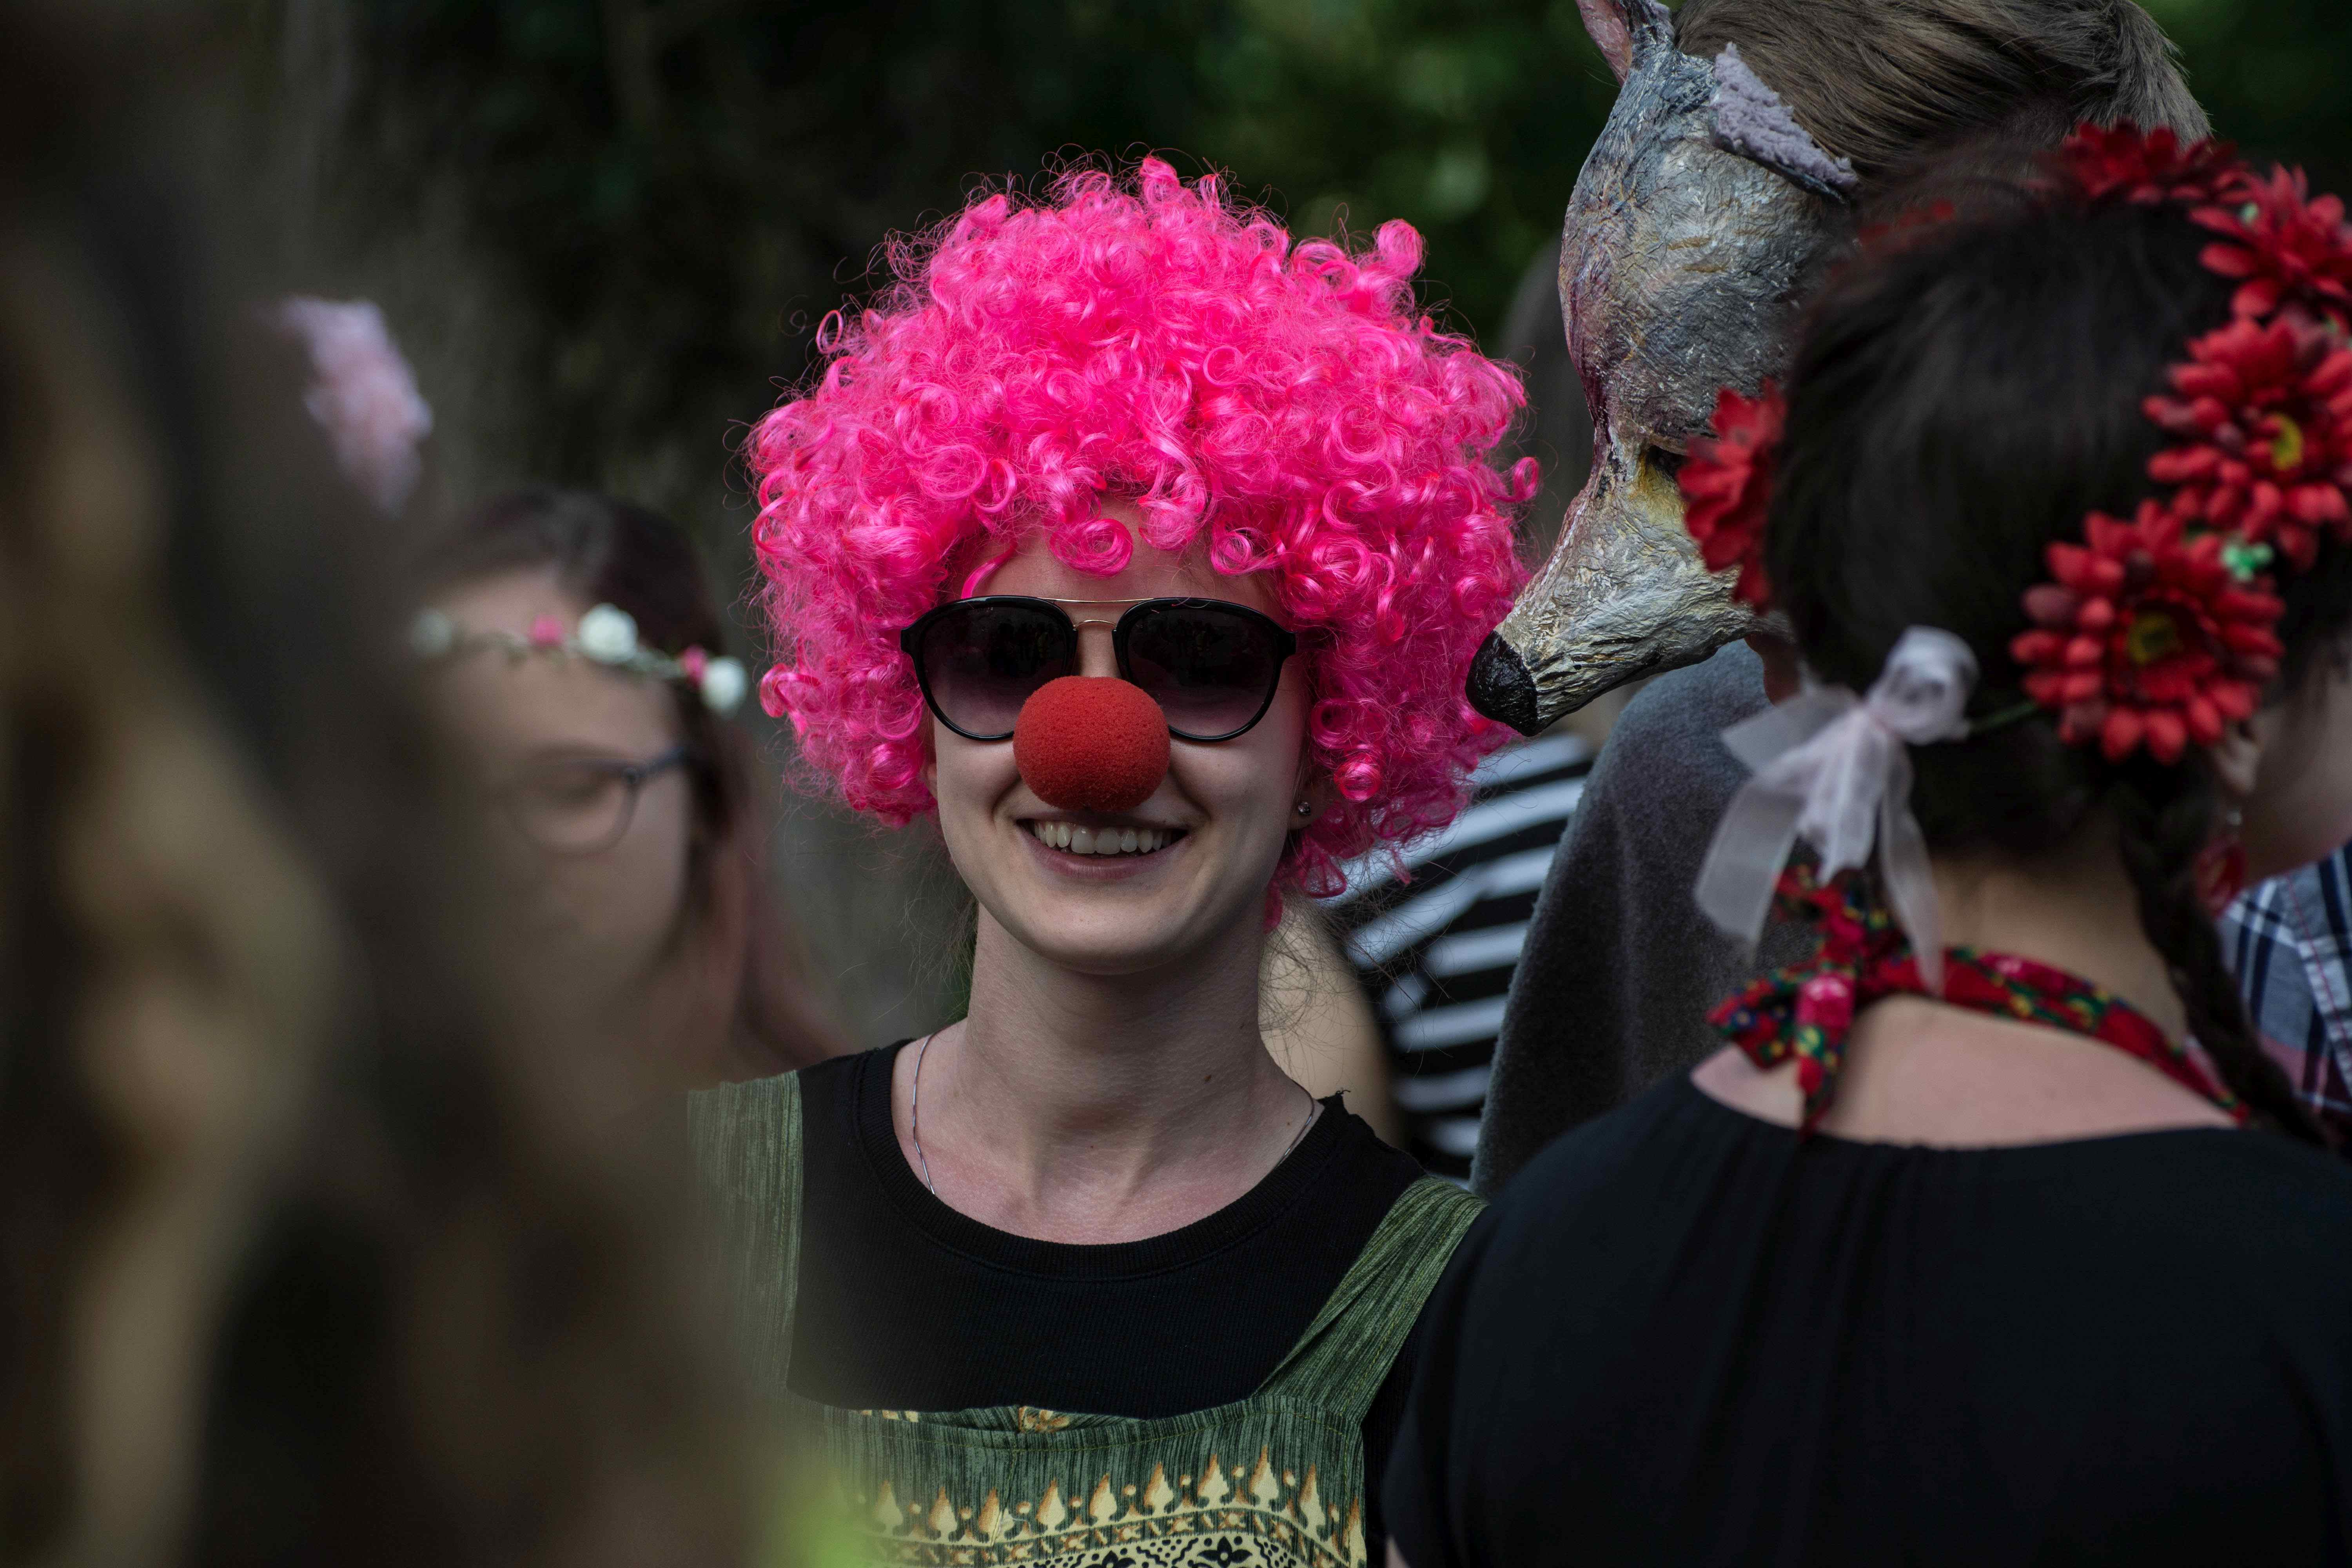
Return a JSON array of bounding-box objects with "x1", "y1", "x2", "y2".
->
[{"x1": 1698, "y1": 625, "x2": 1976, "y2": 992}]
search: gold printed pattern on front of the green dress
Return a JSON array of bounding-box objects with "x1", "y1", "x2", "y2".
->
[{"x1": 842, "y1": 1448, "x2": 1367, "y2": 1568}]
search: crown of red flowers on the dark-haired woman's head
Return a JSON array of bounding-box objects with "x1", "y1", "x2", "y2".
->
[{"x1": 1682, "y1": 125, "x2": 2352, "y2": 762}]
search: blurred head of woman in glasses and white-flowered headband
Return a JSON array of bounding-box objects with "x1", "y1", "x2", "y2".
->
[{"x1": 409, "y1": 489, "x2": 844, "y2": 1089}]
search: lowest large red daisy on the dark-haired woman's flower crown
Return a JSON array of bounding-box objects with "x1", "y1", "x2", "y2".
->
[{"x1": 2009, "y1": 501, "x2": 2284, "y2": 762}]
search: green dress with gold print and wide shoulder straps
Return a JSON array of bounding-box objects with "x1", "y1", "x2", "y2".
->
[{"x1": 689, "y1": 1077, "x2": 1482, "y2": 1568}]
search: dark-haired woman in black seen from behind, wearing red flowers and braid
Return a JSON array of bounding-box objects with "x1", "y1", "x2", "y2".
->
[{"x1": 1385, "y1": 127, "x2": 2352, "y2": 1568}]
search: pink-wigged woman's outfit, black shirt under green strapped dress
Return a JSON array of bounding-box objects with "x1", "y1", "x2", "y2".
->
[{"x1": 689, "y1": 1051, "x2": 1482, "y2": 1568}]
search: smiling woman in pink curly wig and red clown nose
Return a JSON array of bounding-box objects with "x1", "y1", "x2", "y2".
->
[{"x1": 696, "y1": 160, "x2": 1534, "y2": 1563}]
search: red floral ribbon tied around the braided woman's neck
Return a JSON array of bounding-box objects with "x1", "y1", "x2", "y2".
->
[{"x1": 1708, "y1": 865, "x2": 2246, "y2": 1133}]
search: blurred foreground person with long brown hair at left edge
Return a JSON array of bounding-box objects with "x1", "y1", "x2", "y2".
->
[{"x1": 0, "y1": 7, "x2": 769, "y2": 1566}]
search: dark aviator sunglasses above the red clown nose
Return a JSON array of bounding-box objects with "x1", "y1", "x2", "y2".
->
[{"x1": 898, "y1": 595, "x2": 1298, "y2": 740}]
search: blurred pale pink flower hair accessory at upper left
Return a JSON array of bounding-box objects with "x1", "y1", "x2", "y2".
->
[{"x1": 275, "y1": 296, "x2": 433, "y2": 517}]
